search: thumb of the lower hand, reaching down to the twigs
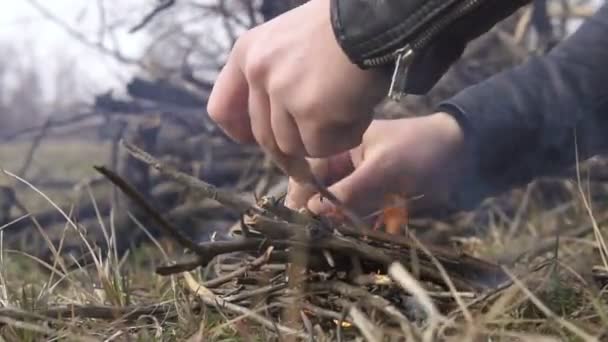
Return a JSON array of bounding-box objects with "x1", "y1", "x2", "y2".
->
[{"x1": 308, "y1": 156, "x2": 386, "y2": 215}]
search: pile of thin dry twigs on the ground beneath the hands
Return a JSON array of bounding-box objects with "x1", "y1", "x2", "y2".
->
[{"x1": 96, "y1": 144, "x2": 509, "y2": 341}]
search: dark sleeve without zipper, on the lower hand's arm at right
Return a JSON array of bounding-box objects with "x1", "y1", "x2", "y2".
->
[{"x1": 440, "y1": 5, "x2": 608, "y2": 207}]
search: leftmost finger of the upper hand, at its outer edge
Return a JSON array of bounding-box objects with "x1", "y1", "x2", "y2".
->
[{"x1": 207, "y1": 44, "x2": 255, "y2": 143}]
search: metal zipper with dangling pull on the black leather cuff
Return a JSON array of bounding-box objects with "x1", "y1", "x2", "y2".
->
[{"x1": 363, "y1": 0, "x2": 483, "y2": 101}]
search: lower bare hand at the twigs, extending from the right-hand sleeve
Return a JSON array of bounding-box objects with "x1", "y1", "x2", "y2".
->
[{"x1": 286, "y1": 113, "x2": 467, "y2": 215}]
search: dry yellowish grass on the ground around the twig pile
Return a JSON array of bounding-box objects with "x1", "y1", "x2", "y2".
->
[{"x1": 0, "y1": 139, "x2": 608, "y2": 341}]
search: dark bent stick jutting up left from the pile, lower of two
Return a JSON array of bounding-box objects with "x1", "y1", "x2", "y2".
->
[{"x1": 95, "y1": 166, "x2": 264, "y2": 262}]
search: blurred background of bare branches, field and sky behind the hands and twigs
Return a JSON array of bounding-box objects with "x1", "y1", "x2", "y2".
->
[{"x1": 0, "y1": 0, "x2": 602, "y2": 257}]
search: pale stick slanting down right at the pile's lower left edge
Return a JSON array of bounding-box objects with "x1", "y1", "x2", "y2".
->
[{"x1": 184, "y1": 273, "x2": 309, "y2": 339}]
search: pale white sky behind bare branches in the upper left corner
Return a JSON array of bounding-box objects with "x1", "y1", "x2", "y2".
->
[{"x1": 0, "y1": 0, "x2": 151, "y2": 100}]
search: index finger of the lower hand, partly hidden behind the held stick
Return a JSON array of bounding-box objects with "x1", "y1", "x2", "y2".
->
[{"x1": 285, "y1": 152, "x2": 354, "y2": 210}]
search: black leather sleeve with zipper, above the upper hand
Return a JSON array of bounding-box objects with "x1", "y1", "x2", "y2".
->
[{"x1": 330, "y1": 0, "x2": 531, "y2": 94}]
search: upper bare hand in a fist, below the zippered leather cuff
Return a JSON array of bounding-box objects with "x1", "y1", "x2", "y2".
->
[{"x1": 208, "y1": 0, "x2": 389, "y2": 177}]
